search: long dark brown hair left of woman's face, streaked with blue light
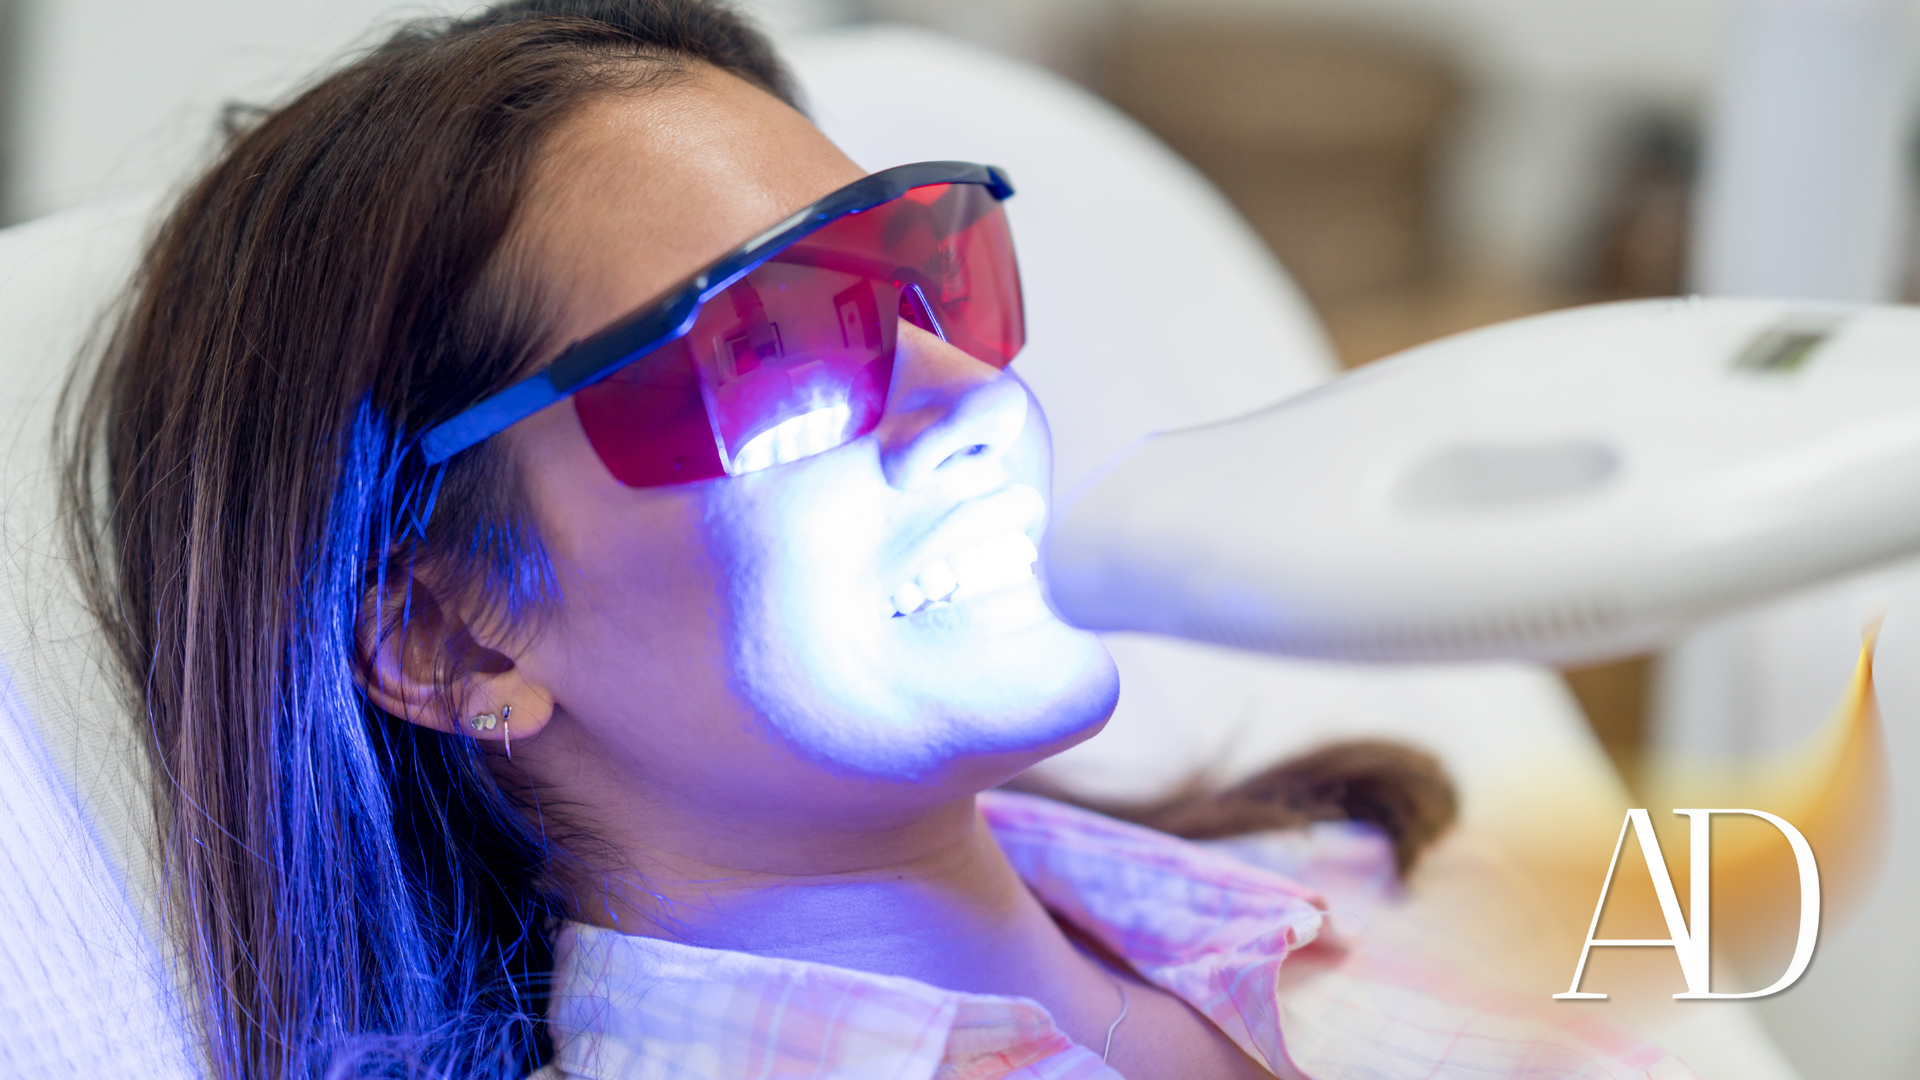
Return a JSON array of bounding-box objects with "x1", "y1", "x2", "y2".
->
[{"x1": 65, "y1": 0, "x2": 791, "y2": 1080}]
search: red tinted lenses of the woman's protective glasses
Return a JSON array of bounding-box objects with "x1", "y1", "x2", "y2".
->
[{"x1": 574, "y1": 184, "x2": 1025, "y2": 486}]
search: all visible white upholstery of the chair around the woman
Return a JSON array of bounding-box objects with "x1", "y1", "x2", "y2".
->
[{"x1": 0, "y1": 29, "x2": 1791, "y2": 1080}]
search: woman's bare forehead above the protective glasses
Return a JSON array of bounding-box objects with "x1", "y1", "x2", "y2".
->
[{"x1": 513, "y1": 63, "x2": 864, "y2": 340}]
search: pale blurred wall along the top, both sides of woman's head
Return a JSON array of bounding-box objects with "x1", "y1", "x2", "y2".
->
[{"x1": 11, "y1": 0, "x2": 1920, "y2": 279}]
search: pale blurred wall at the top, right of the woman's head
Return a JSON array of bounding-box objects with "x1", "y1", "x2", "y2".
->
[{"x1": 868, "y1": 0, "x2": 1734, "y2": 279}]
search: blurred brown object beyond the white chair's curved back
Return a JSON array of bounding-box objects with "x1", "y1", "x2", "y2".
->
[{"x1": 1094, "y1": 6, "x2": 1572, "y2": 374}]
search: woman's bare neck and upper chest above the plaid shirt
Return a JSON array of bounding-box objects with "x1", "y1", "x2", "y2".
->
[{"x1": 545, "y1": 768, "x2": 1269, "y2": 1080}]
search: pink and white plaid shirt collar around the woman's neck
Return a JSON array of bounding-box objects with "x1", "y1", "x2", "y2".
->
[{"x1": 551, "y1": 792, "x2": 1325, "y2": 1080}]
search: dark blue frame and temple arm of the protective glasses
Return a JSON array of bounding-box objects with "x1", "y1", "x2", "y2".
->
[{"x1": 420, "y1": 161, "x2": 1014, "y2": 465}]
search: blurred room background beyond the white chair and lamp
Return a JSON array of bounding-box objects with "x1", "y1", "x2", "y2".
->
[{"x1": 0, "y1": 0, "x2": 1920, "y2": 1076}]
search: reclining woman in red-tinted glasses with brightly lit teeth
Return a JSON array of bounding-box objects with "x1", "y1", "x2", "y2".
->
[{"x1": 69, "y1": 0, "x2": 1681, "y2": 1078}]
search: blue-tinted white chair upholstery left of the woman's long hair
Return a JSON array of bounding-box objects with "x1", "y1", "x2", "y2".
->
[{"x1": 0, "y1": 195, "x2": 200, "y2": 1080}]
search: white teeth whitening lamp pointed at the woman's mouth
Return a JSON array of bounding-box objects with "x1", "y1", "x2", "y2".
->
[{"x1": 1041, "y1": 300, "x2": 1920, "y2": 665}]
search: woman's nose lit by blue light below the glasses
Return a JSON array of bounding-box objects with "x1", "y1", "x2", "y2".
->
[{"x1": 876, "y1": 321, "x2": 1027, "y2": 490}]
